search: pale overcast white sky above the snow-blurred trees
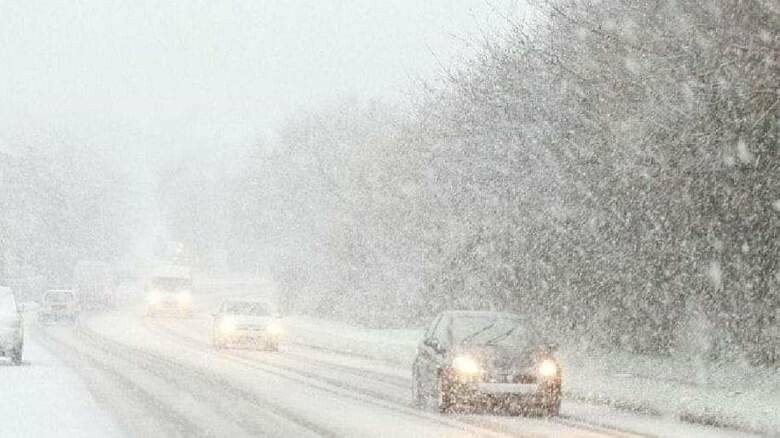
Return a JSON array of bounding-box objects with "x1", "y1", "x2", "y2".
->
[{"x1": 0, "y1": 0, "x2": 516, "y2": 163}]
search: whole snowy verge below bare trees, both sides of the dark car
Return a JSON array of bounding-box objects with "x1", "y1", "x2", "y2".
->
[{"x1": 286, "y1": 317, "x2": 780, "y2": 436}]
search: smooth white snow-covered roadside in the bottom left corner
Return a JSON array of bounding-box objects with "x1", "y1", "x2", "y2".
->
[{"x1": 0, "y1": 330, "x2": 123, "y2": 438}]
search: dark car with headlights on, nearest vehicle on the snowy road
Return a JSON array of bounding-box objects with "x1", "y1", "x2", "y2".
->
[{"x1": 412, "y1": 311, "x2": 562, "y2": 416}]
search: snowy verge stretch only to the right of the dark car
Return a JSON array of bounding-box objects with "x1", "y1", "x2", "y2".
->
[{"x1": 564, "y1": 351, "x2": 780, "y2": 436}]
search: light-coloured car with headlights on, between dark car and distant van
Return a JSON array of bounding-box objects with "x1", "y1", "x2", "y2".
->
[{"x1": 212, "y1": 300, "x2": 284, "y2": 351}]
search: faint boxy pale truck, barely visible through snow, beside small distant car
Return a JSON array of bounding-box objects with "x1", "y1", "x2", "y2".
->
[{"x1": 73, "y1": 261, "x2": 116, "y2": 309}]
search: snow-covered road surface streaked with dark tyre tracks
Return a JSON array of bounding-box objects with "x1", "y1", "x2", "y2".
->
[{"x1": 22, "y1": 298, "x2": 760, "y2": 437}]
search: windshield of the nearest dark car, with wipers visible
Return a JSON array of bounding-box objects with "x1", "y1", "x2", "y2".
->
[{"x1": 450, "y1": 315, "x2": 523, "y2": 345}]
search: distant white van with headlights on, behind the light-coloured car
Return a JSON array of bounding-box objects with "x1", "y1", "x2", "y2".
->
[{"x1": 146, "y1": 265, "x2": 192, "y2": 317}]
